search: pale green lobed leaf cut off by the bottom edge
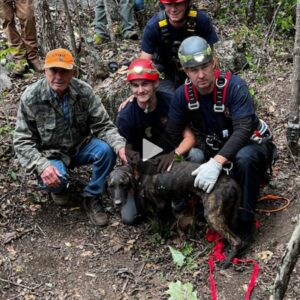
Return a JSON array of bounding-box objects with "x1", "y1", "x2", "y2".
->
[{"x1": 166, "y1": 280, "x2": 198, "y2": 300}]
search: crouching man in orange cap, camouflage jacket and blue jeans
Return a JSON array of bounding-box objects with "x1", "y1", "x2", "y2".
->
[{"x1": 14, "y1": 49, "x2": 127, "y2": 225}]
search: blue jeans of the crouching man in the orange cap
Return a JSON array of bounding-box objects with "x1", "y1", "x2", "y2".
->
[{"x1": 41, "y1": 138, "x2": 116, "y2": 197}]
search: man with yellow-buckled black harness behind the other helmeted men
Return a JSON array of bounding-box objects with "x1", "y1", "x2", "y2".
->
[{"x1": 141, "y1": 0, "x2": 218, "y2": 93}]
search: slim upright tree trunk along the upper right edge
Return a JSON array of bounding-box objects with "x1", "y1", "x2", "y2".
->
[{"x1": 287, "y1": 1, "x2": 300, "y2": 150}]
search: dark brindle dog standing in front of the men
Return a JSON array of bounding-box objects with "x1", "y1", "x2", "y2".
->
[{"x1": 108, "y1": 162, "x2": 244, "y2": 267}]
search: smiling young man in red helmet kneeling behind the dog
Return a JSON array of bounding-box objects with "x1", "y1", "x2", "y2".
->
[{"x1": 116, "y1": 58, "x2": 204, "y2": 224}]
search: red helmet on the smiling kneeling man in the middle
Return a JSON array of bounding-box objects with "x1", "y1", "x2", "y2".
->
[{"x1": 127, "y1": 58, "x2": 159, "y2": 81}]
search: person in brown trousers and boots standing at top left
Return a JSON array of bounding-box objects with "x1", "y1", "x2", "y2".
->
[{"x1": 0, "y1": 0, "x2": 42, "y2": 75}]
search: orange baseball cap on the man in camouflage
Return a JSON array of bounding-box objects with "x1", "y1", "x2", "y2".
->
[{"x1": 44, "y1": 48, "x2": 75, "y2": 70}]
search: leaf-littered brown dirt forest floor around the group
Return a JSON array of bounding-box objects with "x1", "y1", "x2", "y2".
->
[{"x1": 0, "y1": 2, "x2": 300, "y2": 300}]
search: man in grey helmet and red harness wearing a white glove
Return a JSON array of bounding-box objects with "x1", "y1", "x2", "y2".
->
[{"x1": 157, "y1": 37, "x2": 276, "y2": 242}]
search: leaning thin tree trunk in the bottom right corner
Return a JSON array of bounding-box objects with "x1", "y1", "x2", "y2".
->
[{"x1": 270, "y1": 215, "x2": 300, "y2": 300}]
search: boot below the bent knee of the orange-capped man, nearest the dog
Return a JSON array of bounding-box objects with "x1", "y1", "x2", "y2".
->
[{"x1": 83, "y1": 196, "x2": 108, "y2": 226}]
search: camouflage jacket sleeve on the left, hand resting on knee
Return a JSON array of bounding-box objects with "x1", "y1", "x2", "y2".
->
[{"x1": 13, "y1": 91, "x2": 50, "y2": 174}]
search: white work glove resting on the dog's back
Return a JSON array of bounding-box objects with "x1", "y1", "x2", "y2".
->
[{"x1": 192, "y1": 158, "x2": 223, "y2": 193}]
